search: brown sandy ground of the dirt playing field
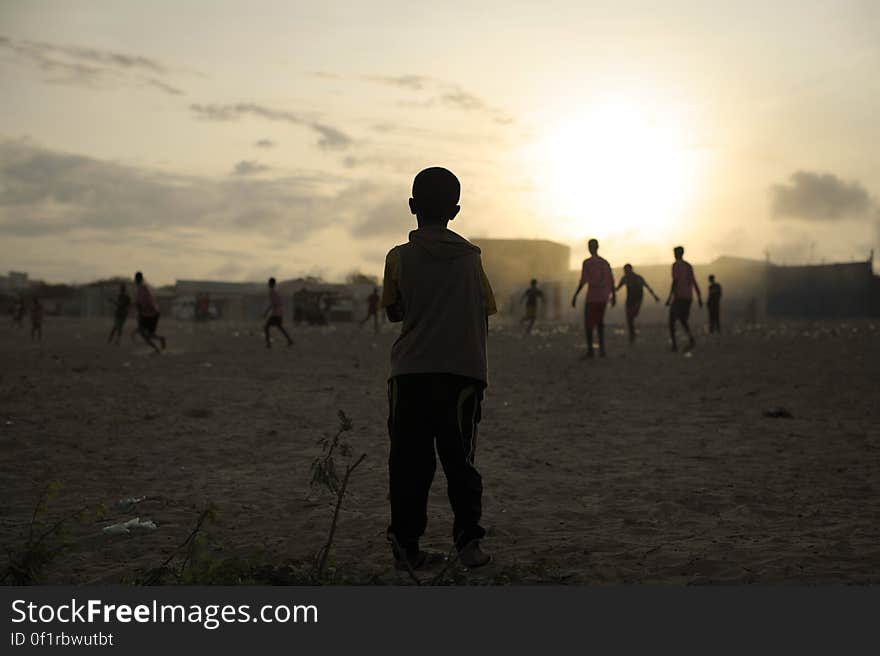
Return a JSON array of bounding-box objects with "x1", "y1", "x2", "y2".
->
[{"x1": 0, "y1": 316, "x2": 880, "y2": 584}]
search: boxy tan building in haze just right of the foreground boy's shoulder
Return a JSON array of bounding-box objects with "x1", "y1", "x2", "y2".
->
[{"x1": 471, "y1": 239, "x2": 571, "y2": 319}]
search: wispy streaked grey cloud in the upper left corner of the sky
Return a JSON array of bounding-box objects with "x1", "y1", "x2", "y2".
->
[{"x1": 0, "y1": 36, "x2": 183, "y2": 96}]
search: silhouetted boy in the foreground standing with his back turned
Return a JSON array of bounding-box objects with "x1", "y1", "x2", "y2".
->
[{"x1": 382, "y1": 167, "x2": 496, "y2": 568}]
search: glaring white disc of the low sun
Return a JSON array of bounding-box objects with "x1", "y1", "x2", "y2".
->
[{"x1": 529, "y1": 103, "x2": 697, "y2": 241}]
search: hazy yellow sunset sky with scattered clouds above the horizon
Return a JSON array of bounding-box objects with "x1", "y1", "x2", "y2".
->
[{"x1": 0, "y1": 0, "x2": 880, "y2": 283}]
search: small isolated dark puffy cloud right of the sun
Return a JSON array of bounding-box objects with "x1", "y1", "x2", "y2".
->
[{"x1": 770, "y1": 171, "x2": 876, "y2": 221}]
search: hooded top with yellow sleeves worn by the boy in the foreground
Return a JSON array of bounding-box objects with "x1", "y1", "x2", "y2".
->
[{"x1": 382, "y1": 226, "x2": 497, "y2": 384}]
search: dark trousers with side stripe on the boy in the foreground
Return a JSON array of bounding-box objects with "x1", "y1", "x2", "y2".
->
[{"x1": 388, "y1": 374, "x2": 485, "y2": 548}]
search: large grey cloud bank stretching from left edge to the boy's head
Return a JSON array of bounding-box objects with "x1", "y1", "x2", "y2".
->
[{"x1": 0, "y1": 140, "x2": 408, "y2": 251}]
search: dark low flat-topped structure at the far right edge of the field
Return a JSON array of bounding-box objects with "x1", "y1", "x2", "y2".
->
[{"x1": 767, "y1": 261, "x2": 880, "y2": 319}]
